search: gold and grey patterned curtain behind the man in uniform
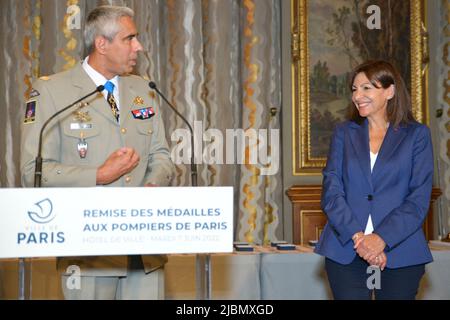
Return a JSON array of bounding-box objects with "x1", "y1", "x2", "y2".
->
[{"x1": 0, "y1": 0, "x2": 283, "y2": 243}]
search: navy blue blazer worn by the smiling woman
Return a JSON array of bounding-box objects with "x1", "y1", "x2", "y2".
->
[{"x1": 315, "y1": 119, "x2": 433, "y2": 268}]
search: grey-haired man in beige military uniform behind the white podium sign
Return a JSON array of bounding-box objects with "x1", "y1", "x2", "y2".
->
[{"x1": 20, "y1": 6, "x2": 173, "y2": 299}]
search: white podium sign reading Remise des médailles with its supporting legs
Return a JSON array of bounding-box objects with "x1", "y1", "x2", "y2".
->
[{"x1": 0, "y1": 187, "x2": 233, "y2": 299}]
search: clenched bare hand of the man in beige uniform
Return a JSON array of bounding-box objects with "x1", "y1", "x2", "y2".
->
[{"x1": 97, "y1": 148, "x2": 140, "y2": 185}]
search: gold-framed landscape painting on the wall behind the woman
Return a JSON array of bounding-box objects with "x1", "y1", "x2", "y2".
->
[{"x1": 291, "y1": 0, "x2": 428, "y2": 175}]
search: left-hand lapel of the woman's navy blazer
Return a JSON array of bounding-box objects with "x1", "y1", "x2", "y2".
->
[{"x1": 349, "y1": 120, "x2": 372, "y2": 188}]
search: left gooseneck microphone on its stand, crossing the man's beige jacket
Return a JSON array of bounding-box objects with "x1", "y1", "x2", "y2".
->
[{"x1": 18, "y1": 85, "x2": 105, "y2": 300}]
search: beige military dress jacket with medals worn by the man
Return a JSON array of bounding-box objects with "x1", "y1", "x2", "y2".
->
[{"x1": 20, "y1": 64, "x2": 173, "y2": 276}]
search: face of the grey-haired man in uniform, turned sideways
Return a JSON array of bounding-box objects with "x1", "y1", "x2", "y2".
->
[{"x1": 105, "y1": 17, "x2": 142, "y2": 77}]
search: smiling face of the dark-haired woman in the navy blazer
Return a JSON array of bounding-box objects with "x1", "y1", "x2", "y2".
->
[{"x1": 352, "y1": 72, "x2": 394, "y2": 119}]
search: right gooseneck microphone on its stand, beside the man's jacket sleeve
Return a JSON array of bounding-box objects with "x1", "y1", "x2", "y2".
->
[{"x1": 148, "y1": 81, "x2": 211, "y2": 300}]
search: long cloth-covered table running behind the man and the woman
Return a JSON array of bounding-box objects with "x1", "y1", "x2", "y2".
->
[{"x1": 0, "y1": 247, "x2": 450, "y2": 300}]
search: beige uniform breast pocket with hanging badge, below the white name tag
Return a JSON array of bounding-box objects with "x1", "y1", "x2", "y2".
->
[{"x1": 61, "y1": 123, "x2": 101, "y2": 162}]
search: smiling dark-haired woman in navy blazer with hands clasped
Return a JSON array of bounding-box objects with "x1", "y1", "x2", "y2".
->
[{"x1": 316, "y1": 61, "x2": 433, "y2": 299}]
